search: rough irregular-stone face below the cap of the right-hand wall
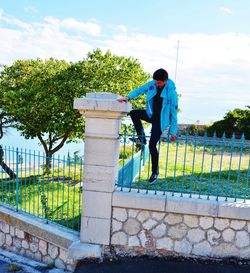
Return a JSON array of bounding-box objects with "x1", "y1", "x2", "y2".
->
[{"x1": 111, "y1": 208, "x2": 250, "y2": 259}]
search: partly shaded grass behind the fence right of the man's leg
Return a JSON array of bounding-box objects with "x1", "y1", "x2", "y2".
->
[{"x1": 124, "y1": 143, "x2": 250, "y2": 199}]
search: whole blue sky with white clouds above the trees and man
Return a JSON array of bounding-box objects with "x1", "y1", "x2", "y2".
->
[{"x1": 0, "y1": 0, "x2": 250, "y2": 124}]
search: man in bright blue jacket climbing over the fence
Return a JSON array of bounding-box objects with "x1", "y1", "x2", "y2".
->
[{"x1": 118, "y1": 68, "x2": 178, "y2": 184}]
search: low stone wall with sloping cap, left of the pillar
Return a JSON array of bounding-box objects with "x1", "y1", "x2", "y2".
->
[{"x1": 0, "y1": 207, "x2": 79, "y2": 271}]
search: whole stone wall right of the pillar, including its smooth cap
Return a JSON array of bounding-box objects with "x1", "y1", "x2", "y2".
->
[{"x1": 111, "y1": 190, "x2": 250, "y2": 259}]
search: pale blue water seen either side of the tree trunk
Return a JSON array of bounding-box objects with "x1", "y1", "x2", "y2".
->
[{"x1": 0, "y1": 128, "x2": 84, "y2": 157}]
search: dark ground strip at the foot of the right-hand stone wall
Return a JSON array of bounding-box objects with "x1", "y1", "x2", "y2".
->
[{"x1": 74, "y1": 255, "x2": 250, "y2": 273}]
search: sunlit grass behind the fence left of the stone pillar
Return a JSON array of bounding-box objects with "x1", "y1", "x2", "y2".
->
[{"x1": 0, "y1": 166, "x2": 82, "y2": 231}]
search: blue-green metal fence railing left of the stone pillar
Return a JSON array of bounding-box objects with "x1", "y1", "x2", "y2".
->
[{"x1": 0, "y1": 147, "x2": 83, "y2": 231}]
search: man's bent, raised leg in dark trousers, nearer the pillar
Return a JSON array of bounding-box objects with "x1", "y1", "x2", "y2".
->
[{"x1": 130, "y1": 110, "x2": 151, "y2": 144}]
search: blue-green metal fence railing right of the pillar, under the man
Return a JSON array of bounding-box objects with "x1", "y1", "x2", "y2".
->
[{"x1": 117, "y1": 131, "x2": 250, "y2": 201}]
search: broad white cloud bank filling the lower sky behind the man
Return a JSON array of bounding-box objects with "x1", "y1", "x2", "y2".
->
[{"x1": 0, "y1": 11, "x2": 250, "y2": 122}]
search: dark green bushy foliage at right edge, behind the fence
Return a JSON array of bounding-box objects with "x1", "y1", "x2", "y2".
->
[{"x1": 208, "y1": 106, "x2": 250, "y2": 139}]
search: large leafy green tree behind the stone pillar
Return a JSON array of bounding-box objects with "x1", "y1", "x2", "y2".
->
[{"x1": 0, "y1": 49, "x2": 149, "y2": 167}]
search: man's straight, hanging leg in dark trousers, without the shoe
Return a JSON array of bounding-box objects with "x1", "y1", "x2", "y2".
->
[{"x1": 149, "y1": 120, "x2": 162, "y2": 174}]
